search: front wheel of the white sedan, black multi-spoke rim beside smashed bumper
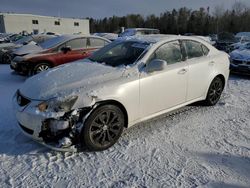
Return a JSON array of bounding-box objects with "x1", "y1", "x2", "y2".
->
[{"x1": 80, "y1": 105, "x2": 125, "y2": 151}]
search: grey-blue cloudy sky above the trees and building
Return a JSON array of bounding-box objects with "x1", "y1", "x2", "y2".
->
[{"x1": 0, "y1": 0, "x2": 250, "y2": 18}]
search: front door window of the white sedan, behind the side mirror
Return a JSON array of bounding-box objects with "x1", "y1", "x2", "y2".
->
[{"x1": 148, "y1": 41, "x2": 182, "y2": 65}]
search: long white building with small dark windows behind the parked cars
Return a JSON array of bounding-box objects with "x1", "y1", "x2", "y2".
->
[{"x1": 0, "y1": 13, "x2": 89, "y2": 34}]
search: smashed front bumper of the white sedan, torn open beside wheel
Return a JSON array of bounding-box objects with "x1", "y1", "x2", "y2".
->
[{"x1": 13, "y1": 92, "x2": 91, "y2": 152}]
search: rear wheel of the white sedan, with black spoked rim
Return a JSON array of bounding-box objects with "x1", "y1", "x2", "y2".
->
[{"x1": 204, "y1": 77, "x2": 224, "y2": 106}]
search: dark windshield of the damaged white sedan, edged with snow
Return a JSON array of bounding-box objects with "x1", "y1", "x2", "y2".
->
[{"x1": 89, "y1": 41, "x2": 149, "y2": 67}]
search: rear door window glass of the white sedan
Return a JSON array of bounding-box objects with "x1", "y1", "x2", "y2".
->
[{"x1": 183, "y1": 41, "x2": 204, "y2": 59}]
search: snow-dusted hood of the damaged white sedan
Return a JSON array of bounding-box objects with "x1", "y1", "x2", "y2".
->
[{"x1": 20, "y1": 61, "x2": 124, "y2": 100}]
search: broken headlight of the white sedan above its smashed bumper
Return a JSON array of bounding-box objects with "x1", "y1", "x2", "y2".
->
[{"x1": 37, "y1": 96, "x2": 78, "y2": 112}]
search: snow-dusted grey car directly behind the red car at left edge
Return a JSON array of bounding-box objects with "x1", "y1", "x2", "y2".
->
[{"x1": 0, "y1": 34, "x2": 55, "y2": 64}]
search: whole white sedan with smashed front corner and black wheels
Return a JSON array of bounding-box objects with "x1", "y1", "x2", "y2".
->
[{"x1": 13, "y1": 35, "x2": 229, "y2": 151}]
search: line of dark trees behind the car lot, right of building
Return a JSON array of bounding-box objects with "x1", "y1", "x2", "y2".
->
[{"x1": 88, "y1": 2, "x2": 250, "y2": 35}]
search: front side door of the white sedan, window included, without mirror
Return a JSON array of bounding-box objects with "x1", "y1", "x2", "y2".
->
[{"x1": 140, "y1": 41, "x2": 188, "y2": 118}]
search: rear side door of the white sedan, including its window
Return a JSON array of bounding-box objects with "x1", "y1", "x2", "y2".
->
[{"x1": 181, "y1": 40, "x2": 215, "y2": 101}]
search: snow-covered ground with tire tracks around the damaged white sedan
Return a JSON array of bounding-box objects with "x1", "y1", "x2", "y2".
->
[{"x1": 0, "y1": 65, "x2": 250, "y2": 188}]
